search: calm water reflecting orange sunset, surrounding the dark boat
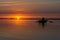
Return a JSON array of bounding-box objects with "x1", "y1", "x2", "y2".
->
[{"x1": 0, "y1": 20, "x2": 60, "y2": 40}]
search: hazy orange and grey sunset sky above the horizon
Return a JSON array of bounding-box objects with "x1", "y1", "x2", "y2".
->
[{"x1": 0, "y1": 0, "x2": 60, "y2": 18}]
